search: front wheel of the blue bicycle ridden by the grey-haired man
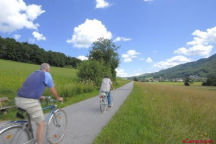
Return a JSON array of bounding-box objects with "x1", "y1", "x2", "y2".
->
[{"x1": 47, "y1": 109, "x2": 67, "y2": 144}]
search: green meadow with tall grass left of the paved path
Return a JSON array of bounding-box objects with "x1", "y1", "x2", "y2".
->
[{"x1": 0, "y1": 59, "x2": 129, "y2": 120}]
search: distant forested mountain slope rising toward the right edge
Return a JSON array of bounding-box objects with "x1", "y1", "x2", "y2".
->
[{"x1": 128, "y1": 54, "x2": 216, "y2": 80}]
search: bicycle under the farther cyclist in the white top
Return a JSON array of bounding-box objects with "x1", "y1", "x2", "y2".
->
[{"x1": 100, "y1": 92, "x2": 113, "y2": 113}]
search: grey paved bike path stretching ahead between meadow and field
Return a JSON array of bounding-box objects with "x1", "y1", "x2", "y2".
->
[{"x1": 60, "y1": 82, "x2": 133, "y2": 144}]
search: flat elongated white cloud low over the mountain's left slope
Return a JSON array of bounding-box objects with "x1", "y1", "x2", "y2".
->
[{"x1": 153, "y1": 55, "x2": 191, "y2": 70}]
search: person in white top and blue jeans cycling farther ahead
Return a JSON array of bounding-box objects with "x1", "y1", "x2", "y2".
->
[{"x1": 100, "y1": 75, "x2": 114, "y2": 107}]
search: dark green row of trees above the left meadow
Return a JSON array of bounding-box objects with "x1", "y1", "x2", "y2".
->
[{"x1": 0, "y1": 36, "x2": 82, "y2": 68}]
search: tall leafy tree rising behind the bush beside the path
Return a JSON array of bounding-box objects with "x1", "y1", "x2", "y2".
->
[{"x1": 89, "y1": 38, "x2": 120, "y2": 81}]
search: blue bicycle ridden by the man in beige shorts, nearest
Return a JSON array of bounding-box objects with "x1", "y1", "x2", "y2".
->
[{"x1": 0, "y1": 96, "x2": 67, "y2": 144}]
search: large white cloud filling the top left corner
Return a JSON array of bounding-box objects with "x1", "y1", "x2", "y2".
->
[{"x1": 0, "y1": 0, "x2": 45, "y2": 32}]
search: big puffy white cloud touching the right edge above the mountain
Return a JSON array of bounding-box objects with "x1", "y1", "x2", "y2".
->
[{"x1": 174, "y1": 27, "x2": 216, "y2": 57}]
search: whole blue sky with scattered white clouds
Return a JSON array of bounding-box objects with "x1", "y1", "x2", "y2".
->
[{"x1": 0, "y1": 0, "x2": 216, "y2": 77}]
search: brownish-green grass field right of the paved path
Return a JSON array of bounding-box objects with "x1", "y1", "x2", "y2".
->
[{"x1": 94, "y1": 82, "x2": 216, "y2": 144}]
